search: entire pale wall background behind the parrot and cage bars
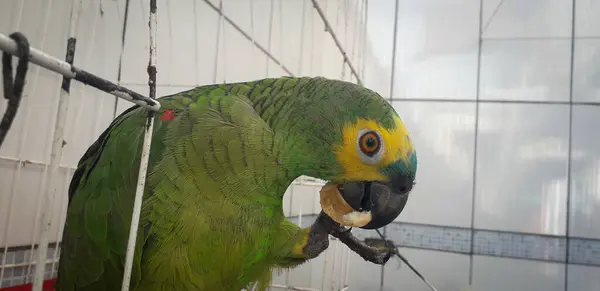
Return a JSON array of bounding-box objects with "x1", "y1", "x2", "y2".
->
[{"x1": 0, "y1": 0, "x2": 600, "y2": 291}]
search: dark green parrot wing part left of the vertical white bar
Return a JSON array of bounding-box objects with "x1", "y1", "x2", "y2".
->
[{"x1": 56, "y1": 101, "x2": 161, "y2": 291}]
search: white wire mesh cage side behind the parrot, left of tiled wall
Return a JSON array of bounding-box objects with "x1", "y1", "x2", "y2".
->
[{"x1": 0, "y1": 0, "x2": 396, "y2": 290}]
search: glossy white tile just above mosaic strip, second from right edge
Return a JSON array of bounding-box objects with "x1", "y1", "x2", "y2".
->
[{"x1": 474, "y1": 103, "x2": 569, "y2": 235}]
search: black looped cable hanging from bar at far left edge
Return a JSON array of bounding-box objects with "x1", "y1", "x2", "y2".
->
[{"x1": 0, "y1": 32, "x2": 29, "y2": 147}]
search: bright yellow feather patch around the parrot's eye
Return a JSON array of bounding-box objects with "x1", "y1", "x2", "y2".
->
[{"x1": 336, "y1": 116, "x2": 414, "y2": 181}]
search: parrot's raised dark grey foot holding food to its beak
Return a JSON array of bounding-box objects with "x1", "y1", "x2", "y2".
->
[{"x1": 314, "y1": 211, "x2": 395, "y2": 265}]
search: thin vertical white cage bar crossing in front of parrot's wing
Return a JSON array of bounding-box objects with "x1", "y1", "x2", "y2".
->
[{"x1": 121, "y1": 0, "x2": 157, "y2": 291}]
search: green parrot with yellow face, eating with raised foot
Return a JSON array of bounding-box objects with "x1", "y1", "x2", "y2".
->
[{"x1": 55, "y1": 77, "x2": 417, "y2": 291}]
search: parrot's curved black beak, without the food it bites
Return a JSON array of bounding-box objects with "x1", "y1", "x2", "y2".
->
[{"x1": 338, "y1": 174, "x2": 414, "y2": 229}]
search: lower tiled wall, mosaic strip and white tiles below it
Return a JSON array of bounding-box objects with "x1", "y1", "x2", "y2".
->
[{"x1": 290, "y1": 215, "x2": 600, "y2": 291}]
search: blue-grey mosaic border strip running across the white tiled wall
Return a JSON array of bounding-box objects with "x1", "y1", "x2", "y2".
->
[{"x1": 289, "y1": 215, "x2": 600, "y2": 267}]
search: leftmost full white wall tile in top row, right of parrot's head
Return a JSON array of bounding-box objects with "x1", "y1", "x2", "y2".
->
[{"x1": 394, "y1": 0, "x2": 480, "y2": 99}]
